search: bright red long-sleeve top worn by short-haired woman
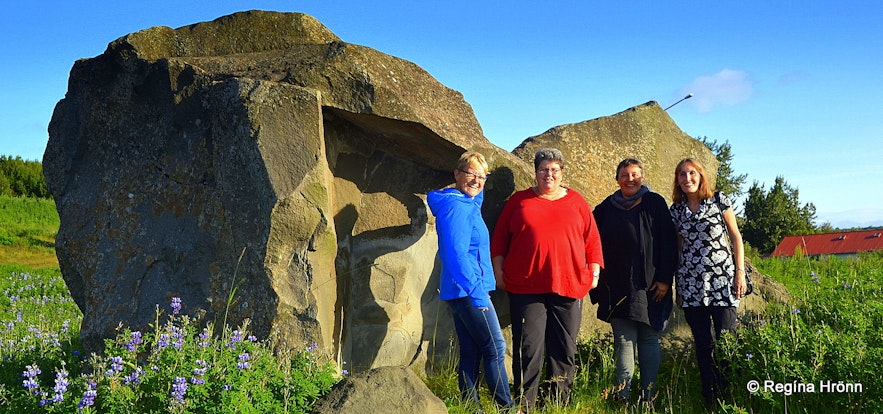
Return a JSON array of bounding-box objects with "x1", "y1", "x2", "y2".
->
[{"x1": 491, "y1": 188, "x2": 604, "y2": 299}]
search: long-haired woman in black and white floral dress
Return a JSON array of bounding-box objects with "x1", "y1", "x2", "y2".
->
[{"x1": 670, "y1": 158, "x2": 747, "y2": 405}]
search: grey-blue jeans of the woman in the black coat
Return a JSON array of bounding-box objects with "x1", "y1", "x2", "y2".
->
[{"x1": 610, "y1": 318, "x2": 661, "y2": 401}]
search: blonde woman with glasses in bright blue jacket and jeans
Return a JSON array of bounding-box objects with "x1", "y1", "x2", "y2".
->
[{"x1": 426, "y1": 151, "x2": 513, "y2": 408}]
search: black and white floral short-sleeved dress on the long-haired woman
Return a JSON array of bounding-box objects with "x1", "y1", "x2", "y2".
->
[{"x1": 669, "y1": 192, "x2": 739, "y2": 308}]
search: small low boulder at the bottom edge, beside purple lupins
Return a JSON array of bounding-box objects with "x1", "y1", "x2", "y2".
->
[{"x1": 313, "y1": 367, "x2": 448, "y2": 414}]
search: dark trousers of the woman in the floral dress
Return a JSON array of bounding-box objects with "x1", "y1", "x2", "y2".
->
[{"x1": 683, "y1": 306, "x2": 736, "y2": 403}]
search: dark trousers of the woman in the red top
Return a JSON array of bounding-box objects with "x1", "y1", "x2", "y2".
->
[{"x1": 509, "y1": 293, "x2": 582, "y2": 411}]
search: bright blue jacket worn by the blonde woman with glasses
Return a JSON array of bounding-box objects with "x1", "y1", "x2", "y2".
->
[{"x1": 426, "y1": 188, "x2": 496, "y2": 308}]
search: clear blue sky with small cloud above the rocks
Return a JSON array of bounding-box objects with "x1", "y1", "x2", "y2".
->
[{"x1": 0, "y1": 0, "x2": 883, "y2": 227}]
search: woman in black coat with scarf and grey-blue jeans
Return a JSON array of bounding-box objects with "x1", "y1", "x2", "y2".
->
[{"x1": 590, "y1": 158, "x2": 677, "y2": 401}]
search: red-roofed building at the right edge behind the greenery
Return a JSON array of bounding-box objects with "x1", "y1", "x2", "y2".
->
[{"x1": 770, "y1": 230, "x2": 883, "y2": 257}]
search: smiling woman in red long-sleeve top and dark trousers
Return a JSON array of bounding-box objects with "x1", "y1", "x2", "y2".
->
[{"x1": 491, "y1": 148, "x2": 604, "y2": 411}]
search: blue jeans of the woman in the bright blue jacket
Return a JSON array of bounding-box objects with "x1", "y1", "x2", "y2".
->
[{"x1": 446, "y1": 297, "x2": 513, "y2": 408}]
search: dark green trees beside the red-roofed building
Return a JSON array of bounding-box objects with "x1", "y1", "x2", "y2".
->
[{"x1": 697, "y1": 137, "x2": 834, "y2": 254}]
